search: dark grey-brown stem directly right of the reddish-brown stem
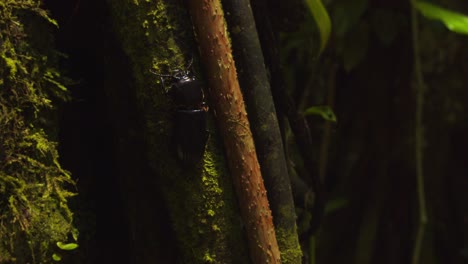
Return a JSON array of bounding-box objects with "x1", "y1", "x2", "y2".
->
[{"x1": 223, "y1": 0, "x2": 302, "y2": 263}]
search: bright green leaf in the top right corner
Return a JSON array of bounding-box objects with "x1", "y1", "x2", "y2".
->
[{"x1": 412, "y1": 1, "x2": 468, "y2": 35}]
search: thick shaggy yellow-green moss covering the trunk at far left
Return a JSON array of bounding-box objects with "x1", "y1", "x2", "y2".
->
[{"x1": 0, "y1": 0, "x2": 78, "y2": 263}]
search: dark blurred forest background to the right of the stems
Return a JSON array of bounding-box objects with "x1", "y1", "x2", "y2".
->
[{"x1": 276, "y1": 0, "x2": 468, "y2": 263}]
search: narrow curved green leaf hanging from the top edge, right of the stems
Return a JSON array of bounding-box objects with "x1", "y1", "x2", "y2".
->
[{"x1": 306, "y1": 0, "x2": 331, "y2": 53}]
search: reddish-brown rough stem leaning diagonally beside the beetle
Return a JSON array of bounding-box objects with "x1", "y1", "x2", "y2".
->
[{"x1": 189, "y1": 0, "x2": 281, "y2": 263}]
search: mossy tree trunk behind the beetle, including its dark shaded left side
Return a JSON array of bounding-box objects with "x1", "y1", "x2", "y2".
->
[{"x1": 105, "y1": 0, "x2": 249, "y2": 263}]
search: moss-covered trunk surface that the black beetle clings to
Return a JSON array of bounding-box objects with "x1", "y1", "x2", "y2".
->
[{"x1": 107, "y1": 0, "x2": 249, "y2": 263}]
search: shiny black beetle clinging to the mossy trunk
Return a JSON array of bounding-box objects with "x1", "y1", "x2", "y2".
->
[{"x1": 151, "y1": 62, "x2": 208, "y2": 166}]
